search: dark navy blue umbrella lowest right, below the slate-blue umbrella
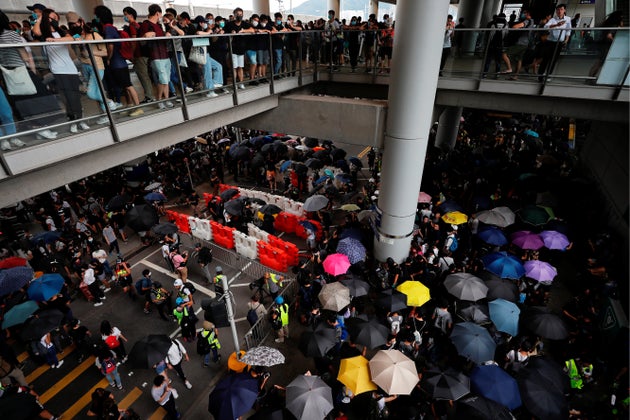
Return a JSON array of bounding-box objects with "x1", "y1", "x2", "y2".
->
[{"x1": 470, "y1": 365, "x2": 522, "y2": 410}]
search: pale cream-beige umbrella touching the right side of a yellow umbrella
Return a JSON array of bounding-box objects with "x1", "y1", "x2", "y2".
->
[{"x1": 369, "y1": 350, "x2": 419, "y2": 395}]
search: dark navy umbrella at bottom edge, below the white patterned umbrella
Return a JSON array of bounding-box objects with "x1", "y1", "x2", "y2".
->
[{"x1": 208, "y1": 373, "x2": 258, "y2": 420}]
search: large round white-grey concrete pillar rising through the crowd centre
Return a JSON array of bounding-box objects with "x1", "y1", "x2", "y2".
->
[{"x1": 374, "y1": 0, "x2": 449, "y2": 262}]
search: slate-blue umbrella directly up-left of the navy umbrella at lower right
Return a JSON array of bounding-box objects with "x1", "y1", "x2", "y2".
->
[{"x1": 451, "y1": 322, "x2": 497, "y2": 363}]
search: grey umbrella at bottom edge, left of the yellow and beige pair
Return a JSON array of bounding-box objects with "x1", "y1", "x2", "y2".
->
[{"x1": 286, "y1": 375, "x2": 333, "y2": 420}]
